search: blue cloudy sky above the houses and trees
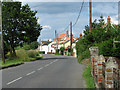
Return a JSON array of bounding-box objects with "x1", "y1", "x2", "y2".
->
[{"x1": 17, "y1": 0, "x2": 118, "y2": 41}]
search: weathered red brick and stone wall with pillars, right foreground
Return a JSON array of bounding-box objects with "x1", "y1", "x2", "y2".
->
[{"x1": 89, "y1": 47, "x2": 120, "y2": 90}]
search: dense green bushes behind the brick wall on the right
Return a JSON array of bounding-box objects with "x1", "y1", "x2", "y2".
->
[{"x1": 76, "y1": 16, "x2": 120, "y2": 61}]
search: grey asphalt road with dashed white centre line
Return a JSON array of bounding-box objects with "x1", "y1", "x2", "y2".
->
[{"x1": 2, "y1": 55, "x2": 86, "y2": 88}]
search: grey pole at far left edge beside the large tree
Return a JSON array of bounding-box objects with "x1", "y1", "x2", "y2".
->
[{"x1": 0, "y1": 1, "x2": 5, "y2": 64}]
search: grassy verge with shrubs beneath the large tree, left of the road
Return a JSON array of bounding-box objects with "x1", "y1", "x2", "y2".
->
[{"x1": 0, "y1": 49, "x2": 43, "y2": 68}]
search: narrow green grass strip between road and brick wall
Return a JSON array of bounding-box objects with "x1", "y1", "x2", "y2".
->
[{"x1": 83, "y1": 65, "x2": 95, "y2": 90}]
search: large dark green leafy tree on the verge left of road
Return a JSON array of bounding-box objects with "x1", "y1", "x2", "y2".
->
[{"x1": 2, "y1": 2, "x2": 42, "y2": 56}]
